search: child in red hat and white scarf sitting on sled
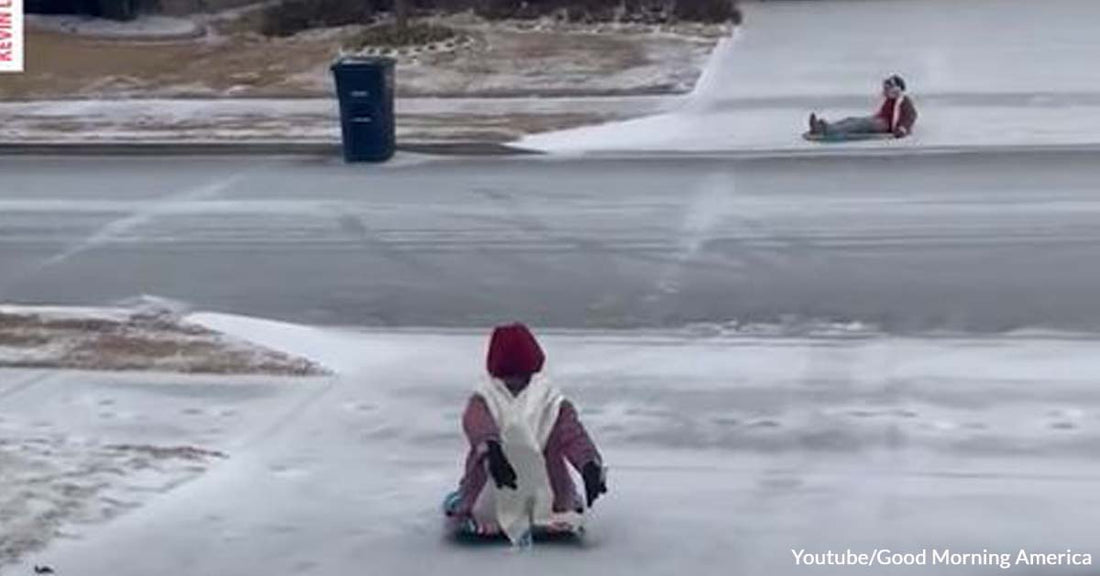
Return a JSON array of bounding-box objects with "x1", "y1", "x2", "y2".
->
[{"x1": 446, "y1": 324, "x2": 607, "y2": 536}]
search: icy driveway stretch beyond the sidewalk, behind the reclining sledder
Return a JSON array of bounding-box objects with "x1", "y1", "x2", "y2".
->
[{"x1": 697, "y1": 0, "x2": 1100, "y2": 100}]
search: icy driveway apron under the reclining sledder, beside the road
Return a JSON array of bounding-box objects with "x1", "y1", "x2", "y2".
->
[{"x1": 518, "y1": 98, "x2": 1100, "y2": 154}]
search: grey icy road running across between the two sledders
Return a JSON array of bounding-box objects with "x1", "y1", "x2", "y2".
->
[{"x1": 0, "y1": 153, "x2": 1100, "y2": 333}]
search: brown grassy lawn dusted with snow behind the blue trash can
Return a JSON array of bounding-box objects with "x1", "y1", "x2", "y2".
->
[{"x1": 0, "y1": 15, "x2": 713, "y2": 100}]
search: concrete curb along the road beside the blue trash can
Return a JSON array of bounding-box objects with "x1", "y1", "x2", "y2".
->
[{"x1": 0, "y1": 142, "x2": 539, "y2": 156}]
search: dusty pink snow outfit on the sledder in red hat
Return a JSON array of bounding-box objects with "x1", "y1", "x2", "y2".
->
[{"x1": 455, "y1": 390, "x2": 602, "y2": 516}]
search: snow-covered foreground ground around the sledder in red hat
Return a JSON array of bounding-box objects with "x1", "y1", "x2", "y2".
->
[{"x1": 0, "y1": 313, "x2": 1100, "y2": 576}]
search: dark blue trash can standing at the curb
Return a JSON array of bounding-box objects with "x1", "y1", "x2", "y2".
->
[{"x1": 332, "y1": 57, "x2": 395, "y2": 162}]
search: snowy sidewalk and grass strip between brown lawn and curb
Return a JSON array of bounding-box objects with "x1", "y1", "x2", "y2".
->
[{"x1": 0, "y1": 97, "x2": 678, "y2": 151}]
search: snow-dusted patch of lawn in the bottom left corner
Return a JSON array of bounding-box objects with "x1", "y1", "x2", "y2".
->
[{"x1": 0, "y1": 369, "x2": 325, "y2": 574}]
